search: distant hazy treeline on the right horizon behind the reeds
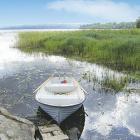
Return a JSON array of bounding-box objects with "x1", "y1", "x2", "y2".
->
[{"x1": 80, "y1": 22, "x2": 136, "y2": 29}]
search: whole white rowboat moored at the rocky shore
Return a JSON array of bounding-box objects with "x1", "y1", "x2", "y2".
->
[{"x1": 35, "y1": 77, "x2": 86, "y2": 124}]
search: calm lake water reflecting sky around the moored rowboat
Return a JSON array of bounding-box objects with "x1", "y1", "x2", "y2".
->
[{"x1": 0, "y1": 32, "x2": 140, "y2": 140}]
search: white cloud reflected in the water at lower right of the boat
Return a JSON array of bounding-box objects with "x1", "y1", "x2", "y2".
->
[{"x1": 84, "y1": 93, "x2": 140, "y2": 136}]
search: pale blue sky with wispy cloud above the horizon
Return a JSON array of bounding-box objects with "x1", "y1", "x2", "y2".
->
[{"x1": 0, "y1": 0, "x2": 140, "y2": 27}]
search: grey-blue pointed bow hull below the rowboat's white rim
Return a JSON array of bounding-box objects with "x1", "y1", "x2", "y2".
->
[{"x1": 39, "y1": 103, "x2": 82, "y2": 124}]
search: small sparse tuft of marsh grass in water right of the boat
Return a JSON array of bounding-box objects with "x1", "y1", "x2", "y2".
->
[{"x1": 80, "y1": 71, "x2": 130, "y2": 93}]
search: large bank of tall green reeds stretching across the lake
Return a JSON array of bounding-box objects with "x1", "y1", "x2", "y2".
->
[{"x1": 17, "y1": 29, "x2": 140, "y2": 76}]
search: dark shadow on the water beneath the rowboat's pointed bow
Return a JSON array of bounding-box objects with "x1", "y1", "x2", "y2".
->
[{"x1": 31, "y1": 105, "x2": 85, "y2": 140}]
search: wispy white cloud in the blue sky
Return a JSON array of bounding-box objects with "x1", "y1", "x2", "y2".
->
[{"x1": 47, "y1": 0, "x2": 140, "y2": 21}]
